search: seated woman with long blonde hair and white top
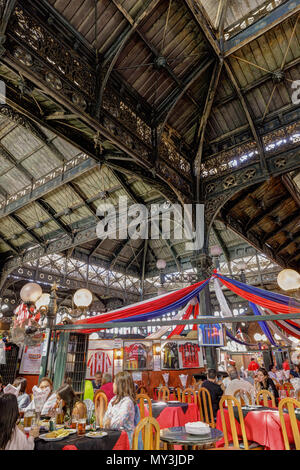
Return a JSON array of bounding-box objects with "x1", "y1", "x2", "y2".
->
[{"x1": 103, "y1": 371, "x2": 136, "y2": 443}]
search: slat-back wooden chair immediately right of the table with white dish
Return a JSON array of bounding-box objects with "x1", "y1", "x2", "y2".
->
[{"x1": 220, "y1": 395, "x2": 263, "y2": 450}]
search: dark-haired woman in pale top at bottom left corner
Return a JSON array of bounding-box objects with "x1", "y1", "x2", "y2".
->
[{"x1": 0, "y1": 393, "x2": 39, "y2": 450}]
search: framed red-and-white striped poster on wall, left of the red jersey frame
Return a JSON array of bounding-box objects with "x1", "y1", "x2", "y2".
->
[{"x1": 86, "y1": 340, "x2": 114, "y2": 379}]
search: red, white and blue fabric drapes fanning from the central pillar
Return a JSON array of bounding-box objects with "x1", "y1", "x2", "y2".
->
[{"x1": 75, "y1": 271, "x2": 300, "y2": 346}]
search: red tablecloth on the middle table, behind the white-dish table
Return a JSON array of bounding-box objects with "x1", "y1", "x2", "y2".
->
[{"x1": 145, "y1": 403, "x2": 200, "y2": 429}]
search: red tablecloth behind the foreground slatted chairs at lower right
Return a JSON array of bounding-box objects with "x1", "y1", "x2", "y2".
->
[{"x1": 216, "y1": 408, "x2": 300, "y2": 450}]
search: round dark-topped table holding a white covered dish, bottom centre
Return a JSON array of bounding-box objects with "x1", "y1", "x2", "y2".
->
[{"x1": 160, "y1": 426, "x2": 223, "y2": 450}]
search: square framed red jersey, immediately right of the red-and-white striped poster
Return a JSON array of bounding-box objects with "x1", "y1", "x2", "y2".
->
[{"x1": 124, "y1": 341, "x2": 153, "y2": 370}]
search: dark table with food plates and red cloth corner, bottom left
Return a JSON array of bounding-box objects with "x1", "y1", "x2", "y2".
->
[{"x1": 34, "y1": 429, "x2": 130, "y2": 450}]
